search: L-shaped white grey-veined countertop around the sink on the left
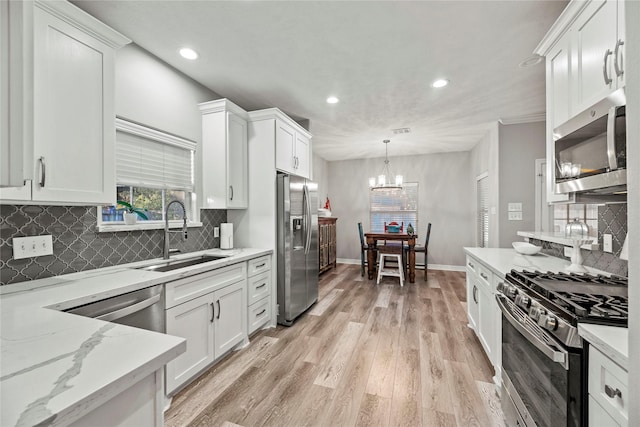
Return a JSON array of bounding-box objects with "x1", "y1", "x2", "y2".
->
[{"x1": 0, "y1": 249, "x2": 272, "y2": 427}]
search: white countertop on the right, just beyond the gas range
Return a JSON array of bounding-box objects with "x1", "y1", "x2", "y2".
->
[{"x1": 464, "y1": 248, "x2": 611, "y2": 277}]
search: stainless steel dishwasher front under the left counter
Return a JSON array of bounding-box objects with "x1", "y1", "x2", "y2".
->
[{"x1": 65, "y1": 285, "x2": 165, "y2": 333}]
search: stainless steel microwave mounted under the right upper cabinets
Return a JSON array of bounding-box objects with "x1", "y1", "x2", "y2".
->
[{"x1": 554, "y1": 89, "x2": 627, "y2": 194}]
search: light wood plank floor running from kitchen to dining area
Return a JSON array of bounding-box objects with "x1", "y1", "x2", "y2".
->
[{"x1": 165, "y1": 264, "x2": 503, "y2": 427}]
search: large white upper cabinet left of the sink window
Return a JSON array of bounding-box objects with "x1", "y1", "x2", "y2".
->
[{"x1": 2, "y1": 1, "x2": 130, "y2": 204}]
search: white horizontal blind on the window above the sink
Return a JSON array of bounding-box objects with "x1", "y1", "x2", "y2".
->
[{"x1": 116, "y1": 119, "x2": 196, "y2": 192}]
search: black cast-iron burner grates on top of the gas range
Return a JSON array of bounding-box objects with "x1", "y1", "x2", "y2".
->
[{"x1": 507, "y1": 270, "x2": 629, "y2": 324}]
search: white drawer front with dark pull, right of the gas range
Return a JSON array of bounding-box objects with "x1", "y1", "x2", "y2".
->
[{"x1": 589, "y1": 346, "x2": 629, "y2": 425}]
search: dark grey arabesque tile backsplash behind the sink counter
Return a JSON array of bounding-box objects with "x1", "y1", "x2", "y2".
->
[{"x1": 0, "y1": 205, "x2": 227, "y2": 285}]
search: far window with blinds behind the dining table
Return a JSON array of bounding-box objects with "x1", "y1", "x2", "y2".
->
[{"x1": 369, "y1": 182, "x2": 419, "y2": 234}]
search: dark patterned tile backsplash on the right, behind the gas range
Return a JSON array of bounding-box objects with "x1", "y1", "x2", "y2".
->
[{"x1": 530, "y1": 203, "x2": 629, "y2": 277}]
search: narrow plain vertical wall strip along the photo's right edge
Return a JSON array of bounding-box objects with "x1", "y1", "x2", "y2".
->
[{"x1": 625, "y1": 1, "x2": 640, "y2": 426}]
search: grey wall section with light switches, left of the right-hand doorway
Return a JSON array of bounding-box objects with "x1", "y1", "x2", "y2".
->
[{"x1": 498, "y1": 122, "x2": 546, "y2": 248}]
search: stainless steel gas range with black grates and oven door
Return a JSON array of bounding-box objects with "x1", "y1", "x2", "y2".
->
[{"x1": 496, "y1": 270, "x2": 628, "y2": 427}]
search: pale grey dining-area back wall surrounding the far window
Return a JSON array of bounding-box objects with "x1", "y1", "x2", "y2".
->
[{"x1": 328, "y1": 152, "x2": 474, "y2": 266}]
